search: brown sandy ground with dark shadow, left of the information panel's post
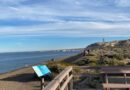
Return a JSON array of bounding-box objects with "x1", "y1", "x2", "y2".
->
[{"x1": 0, "y1": 67, "x2": 40, "y2": 90}]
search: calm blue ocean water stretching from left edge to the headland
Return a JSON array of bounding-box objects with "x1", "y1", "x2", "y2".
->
[{"x1": 0, "y1": 50, "x2": 81, "y2": 73}]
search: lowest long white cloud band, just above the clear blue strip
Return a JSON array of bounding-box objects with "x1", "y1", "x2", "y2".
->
[{"x1": 0, "y1": 22, "x2": 130, "y2": 37}]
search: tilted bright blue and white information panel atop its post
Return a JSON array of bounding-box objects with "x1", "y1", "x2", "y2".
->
[{"x1": 32, "y1": 65, "x2": 51, "y2": 77}]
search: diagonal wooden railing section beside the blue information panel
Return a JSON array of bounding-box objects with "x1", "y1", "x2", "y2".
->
[{"x1": 42, "y1": 67, "x2": 73, "y2": 90}]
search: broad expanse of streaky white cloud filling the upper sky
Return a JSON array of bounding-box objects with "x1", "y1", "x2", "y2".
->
[{"x1": 0, "y1": 0, "x2": 130, "y2": 37}]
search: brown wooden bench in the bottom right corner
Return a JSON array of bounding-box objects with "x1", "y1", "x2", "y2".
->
[{"x1": 101, "y1": 66, "x2": 130, "y2": 90}]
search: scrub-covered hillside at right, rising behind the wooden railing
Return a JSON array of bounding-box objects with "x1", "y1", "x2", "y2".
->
[{"x1": 74, "y1": 39, "x2": 130, "y2": 66}]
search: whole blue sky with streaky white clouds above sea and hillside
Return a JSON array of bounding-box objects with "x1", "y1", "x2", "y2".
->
[{"x1": 0, "y1": 0, "x2": 130, "y2": 52}]
